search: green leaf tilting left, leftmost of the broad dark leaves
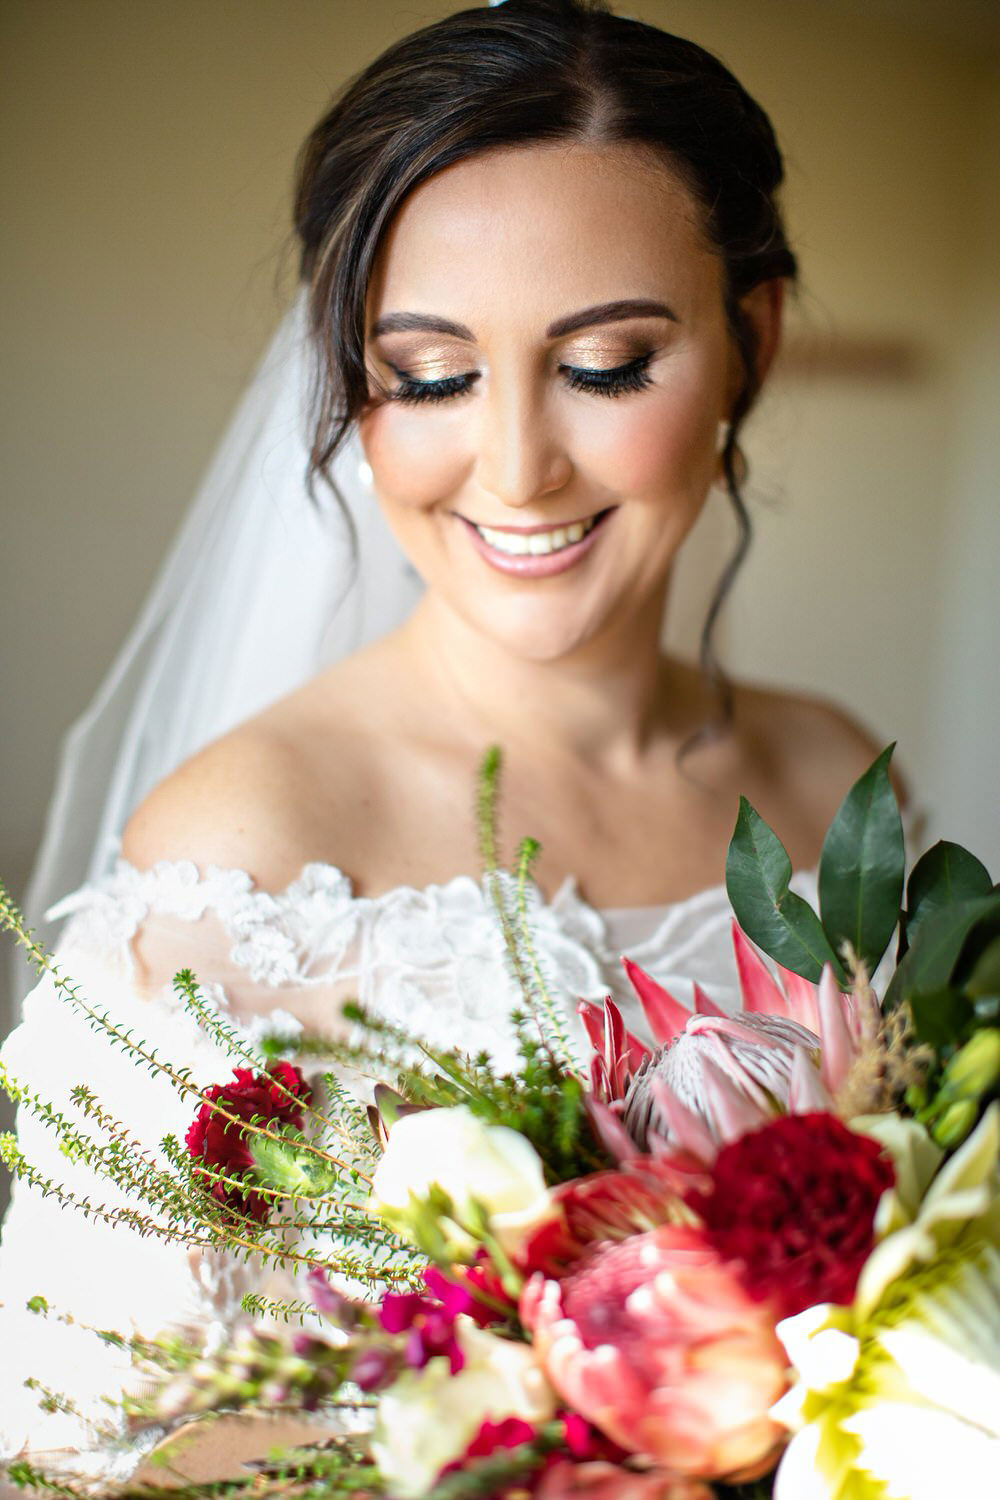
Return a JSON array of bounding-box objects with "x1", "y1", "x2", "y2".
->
[{"x1": 726, "y1": 797, "x2": 846, "y2": 984}]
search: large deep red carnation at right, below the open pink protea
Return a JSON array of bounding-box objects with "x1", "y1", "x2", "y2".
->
[{"x1": 688, "y1": 1113, "x2": 895, "y2": 1317}]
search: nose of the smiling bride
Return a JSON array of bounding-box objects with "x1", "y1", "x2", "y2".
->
[{"x1": 475, "y1": 386, "x2": 573, "y2": 509}]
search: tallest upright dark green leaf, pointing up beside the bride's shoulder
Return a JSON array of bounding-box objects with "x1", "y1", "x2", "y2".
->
[{"x1": 819, "y1": 744, "x2": 906, "y2": 974}]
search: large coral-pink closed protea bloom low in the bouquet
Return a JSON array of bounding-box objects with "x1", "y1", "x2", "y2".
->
[{"x1": 520, "y1": 1224, "x2": 787, "y2": 1482}]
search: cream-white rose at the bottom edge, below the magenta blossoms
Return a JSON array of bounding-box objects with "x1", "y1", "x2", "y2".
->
[{"x1": 372, "y1": 1317, "x2": 556, "y2": 1500}]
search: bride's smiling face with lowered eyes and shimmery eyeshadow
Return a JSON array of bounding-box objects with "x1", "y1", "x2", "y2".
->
[{"x1": 360, "y1": 144, "x2": 758, "y2": 660}]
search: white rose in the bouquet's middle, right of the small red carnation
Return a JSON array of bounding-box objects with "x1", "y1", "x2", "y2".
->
[{"x1": 372, "y1": 1104, "x2": 555, "y2": 1256}]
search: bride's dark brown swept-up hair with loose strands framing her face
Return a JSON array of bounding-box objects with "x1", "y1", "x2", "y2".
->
[{"x1": 295, "y1": 0, "x2": 796, "y2": 738}]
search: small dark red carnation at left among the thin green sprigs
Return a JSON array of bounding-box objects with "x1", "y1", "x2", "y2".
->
[{"x1": 184, "y1": 1062, "x2": 312, "y2": 1223}]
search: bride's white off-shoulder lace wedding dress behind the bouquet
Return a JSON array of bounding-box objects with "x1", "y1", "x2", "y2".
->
[{"x1": 0, "y1": 861, "x2": 816, "y2": 1487}]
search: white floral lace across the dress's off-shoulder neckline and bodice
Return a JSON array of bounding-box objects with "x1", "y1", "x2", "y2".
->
[{"x1": 37, "y1": 860, "x2": 814, "y2": 1065}]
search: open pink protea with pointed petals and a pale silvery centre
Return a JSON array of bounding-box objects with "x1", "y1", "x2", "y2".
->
[{"x1": 580, "y1": 921, "x2": 879, "y2": 1166}]
